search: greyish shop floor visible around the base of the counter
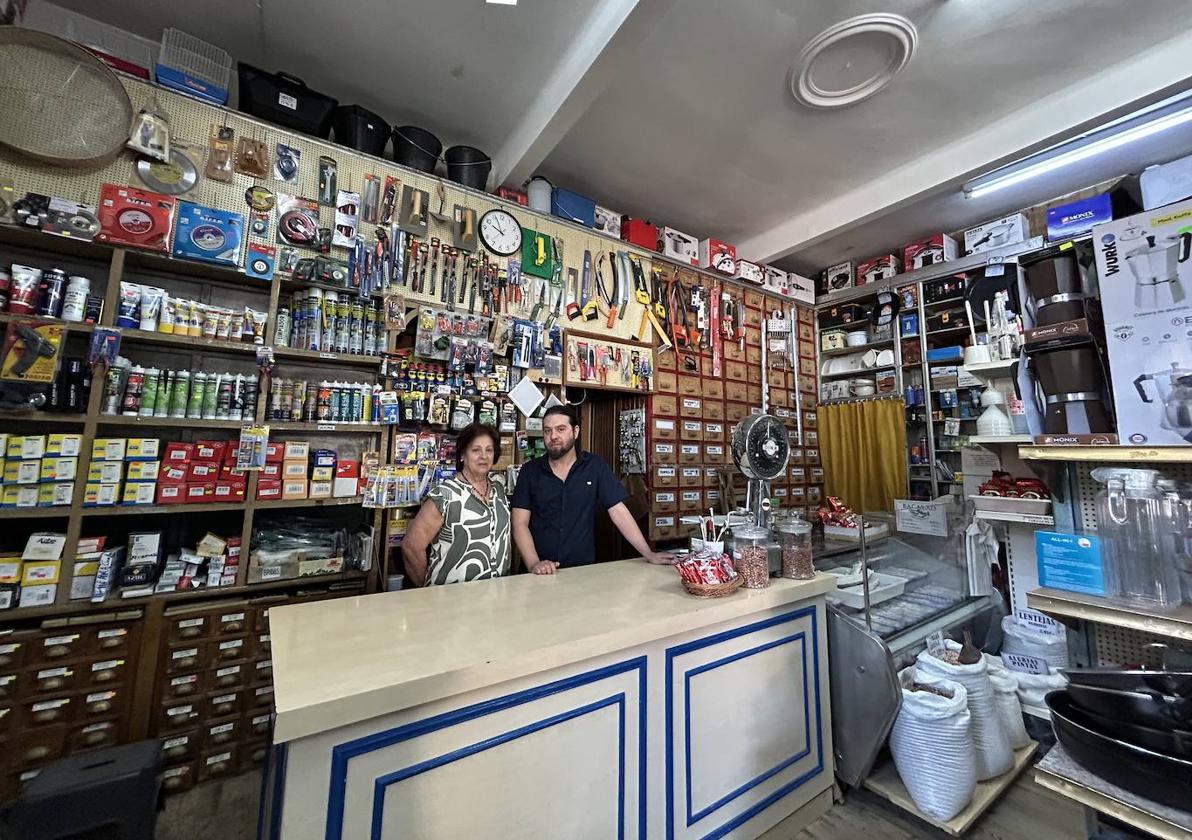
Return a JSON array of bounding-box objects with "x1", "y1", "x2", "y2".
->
[{"x1": 157, "y1": 770, "x2": 1085, "y2": 840}]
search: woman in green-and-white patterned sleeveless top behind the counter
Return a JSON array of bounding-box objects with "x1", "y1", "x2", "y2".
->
[{"x1": 402, "y1": 423, "x2": 509, "y2": 586}]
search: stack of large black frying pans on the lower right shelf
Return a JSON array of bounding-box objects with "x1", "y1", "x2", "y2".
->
[{"x1": 1047, "y1": 668, "x2": 1192, "y2": 809}]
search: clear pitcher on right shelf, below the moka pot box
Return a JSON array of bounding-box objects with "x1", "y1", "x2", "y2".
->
[{"x1": 1092, "y1": 467, "x2": 1181, "y2": 608}]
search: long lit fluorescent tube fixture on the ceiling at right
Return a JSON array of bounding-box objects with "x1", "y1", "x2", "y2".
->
[{"x1": 962, "y1": 94, "x2": 1192, "y2": 198}]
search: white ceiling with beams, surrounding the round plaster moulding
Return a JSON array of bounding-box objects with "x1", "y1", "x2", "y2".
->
[{"x1": 30, "y1": 0, "x2": 1192, "y2": 270}]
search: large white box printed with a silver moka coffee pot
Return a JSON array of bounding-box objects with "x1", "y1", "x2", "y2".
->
[{"x1": 1092, "y1": 200, "x2": 1192, "y2": 446}]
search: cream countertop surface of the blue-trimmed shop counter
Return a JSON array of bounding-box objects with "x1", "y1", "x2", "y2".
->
[{"x1": 269, "y1": 560, "x2": 836, "y2": 742}]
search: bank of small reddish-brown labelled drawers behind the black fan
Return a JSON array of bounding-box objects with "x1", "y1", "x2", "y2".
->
[{"x1": 646, "y1": 292, "x2": 824, "y2": 541}]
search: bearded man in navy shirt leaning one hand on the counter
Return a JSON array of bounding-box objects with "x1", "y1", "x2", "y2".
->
[{"x1": 513, "y1": 405, "x2": 673, "y2": 574}]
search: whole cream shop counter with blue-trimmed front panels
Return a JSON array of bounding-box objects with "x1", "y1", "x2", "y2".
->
[{"x1": 261, "y1": 560, "x2": 834, "y2": 840}]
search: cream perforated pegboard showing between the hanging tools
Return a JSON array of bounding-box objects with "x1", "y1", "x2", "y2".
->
[{"x1": 0, "y1": 69, "x2": 810, "y2": 343}]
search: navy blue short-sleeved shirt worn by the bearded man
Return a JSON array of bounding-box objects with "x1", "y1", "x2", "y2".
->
[{"x1": 513, "y1": 452, "x2": 629, "y2": 567}]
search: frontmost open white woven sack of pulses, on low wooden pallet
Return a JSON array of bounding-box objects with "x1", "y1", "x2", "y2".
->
[{"x1": 890, "y1": 666, "x2": 976, "y2": 820}]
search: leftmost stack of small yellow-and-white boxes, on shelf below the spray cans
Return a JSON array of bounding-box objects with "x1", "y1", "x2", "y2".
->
[{"x1": 0, "y1": 434, "x2": 82, "y2": 508}]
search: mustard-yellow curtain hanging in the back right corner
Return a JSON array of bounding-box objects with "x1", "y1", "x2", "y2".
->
[{"x1": 818, "y1": 399, "x2": 907, "y2": 514}]
